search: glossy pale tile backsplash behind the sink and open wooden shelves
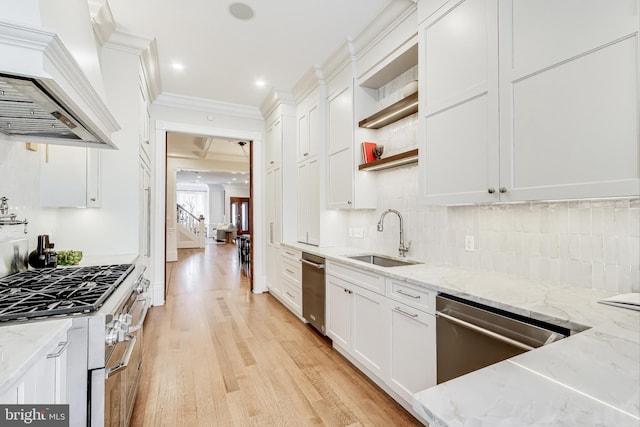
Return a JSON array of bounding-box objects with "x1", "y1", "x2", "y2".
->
[{"x1": 349, "y1": 115, "x2": 640, "y2": 293}]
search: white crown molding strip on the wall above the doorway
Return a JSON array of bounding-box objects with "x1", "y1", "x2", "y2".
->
[{"x1": 154, "y1": 92, "x2": 263, "y2": 120}]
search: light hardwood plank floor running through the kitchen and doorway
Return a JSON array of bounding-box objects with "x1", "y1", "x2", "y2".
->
[{"x1": 132, "y1": 244, "x2": 420, "y2": 426}]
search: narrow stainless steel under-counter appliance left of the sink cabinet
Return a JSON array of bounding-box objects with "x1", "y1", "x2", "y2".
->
[{"x1": 301, "y1": 252, "x2": 325, "y2": 335}]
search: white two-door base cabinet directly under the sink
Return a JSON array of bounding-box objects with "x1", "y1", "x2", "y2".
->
[{"x1": 326, "y1": 263, "x2": 389, "y2": 378}]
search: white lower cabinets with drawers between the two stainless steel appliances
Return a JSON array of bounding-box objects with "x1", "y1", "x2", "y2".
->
[{"x1": 326, "y1": 262, "x2": 436, "y2": 422}]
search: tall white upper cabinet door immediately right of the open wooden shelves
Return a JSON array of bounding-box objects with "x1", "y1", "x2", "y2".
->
[{"x1": 419, "y1": 0, "x2": 499, "y2": 203}]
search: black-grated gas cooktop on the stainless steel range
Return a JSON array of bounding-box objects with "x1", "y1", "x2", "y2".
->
[{"x1": 0, "y1": 264, "x2": 134, "y2": 322}]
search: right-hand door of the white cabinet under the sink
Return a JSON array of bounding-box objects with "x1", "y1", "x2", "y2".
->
[{"x1": 349, "y1": 285, "x2": 389, "y2": 378}]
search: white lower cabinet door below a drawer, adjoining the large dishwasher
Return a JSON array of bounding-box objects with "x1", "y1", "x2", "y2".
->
[{"x1": 387, "y1": 300, "x2": 436, "y2": 403}]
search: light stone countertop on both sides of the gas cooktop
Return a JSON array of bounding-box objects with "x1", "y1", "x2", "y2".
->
[{"x1": 0, "y1": 254, "x2": 138, "y2": 395}]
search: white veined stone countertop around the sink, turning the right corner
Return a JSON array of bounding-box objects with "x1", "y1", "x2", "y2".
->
[{"x1": 283, "y1": 243, "x2": 640, "y2": 427}]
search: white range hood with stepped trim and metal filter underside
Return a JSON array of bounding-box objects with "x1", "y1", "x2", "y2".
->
[{"x1": 0, "y1": 22, "x2": 120, "y2": 148}]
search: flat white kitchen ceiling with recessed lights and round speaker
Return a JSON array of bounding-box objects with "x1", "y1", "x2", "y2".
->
[{"x1": 109, "y1": 0, "x2": 392, "y2": 107}]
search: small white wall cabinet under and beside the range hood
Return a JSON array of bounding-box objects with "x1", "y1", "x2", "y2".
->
[{"x1": 40, "y1": 145, "x2": 101, "y2": 207}]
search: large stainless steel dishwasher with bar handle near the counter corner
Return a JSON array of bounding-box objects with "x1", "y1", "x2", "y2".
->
[{"x1": 436, "y1": 295, "x2": 571, "y2": 384}]
